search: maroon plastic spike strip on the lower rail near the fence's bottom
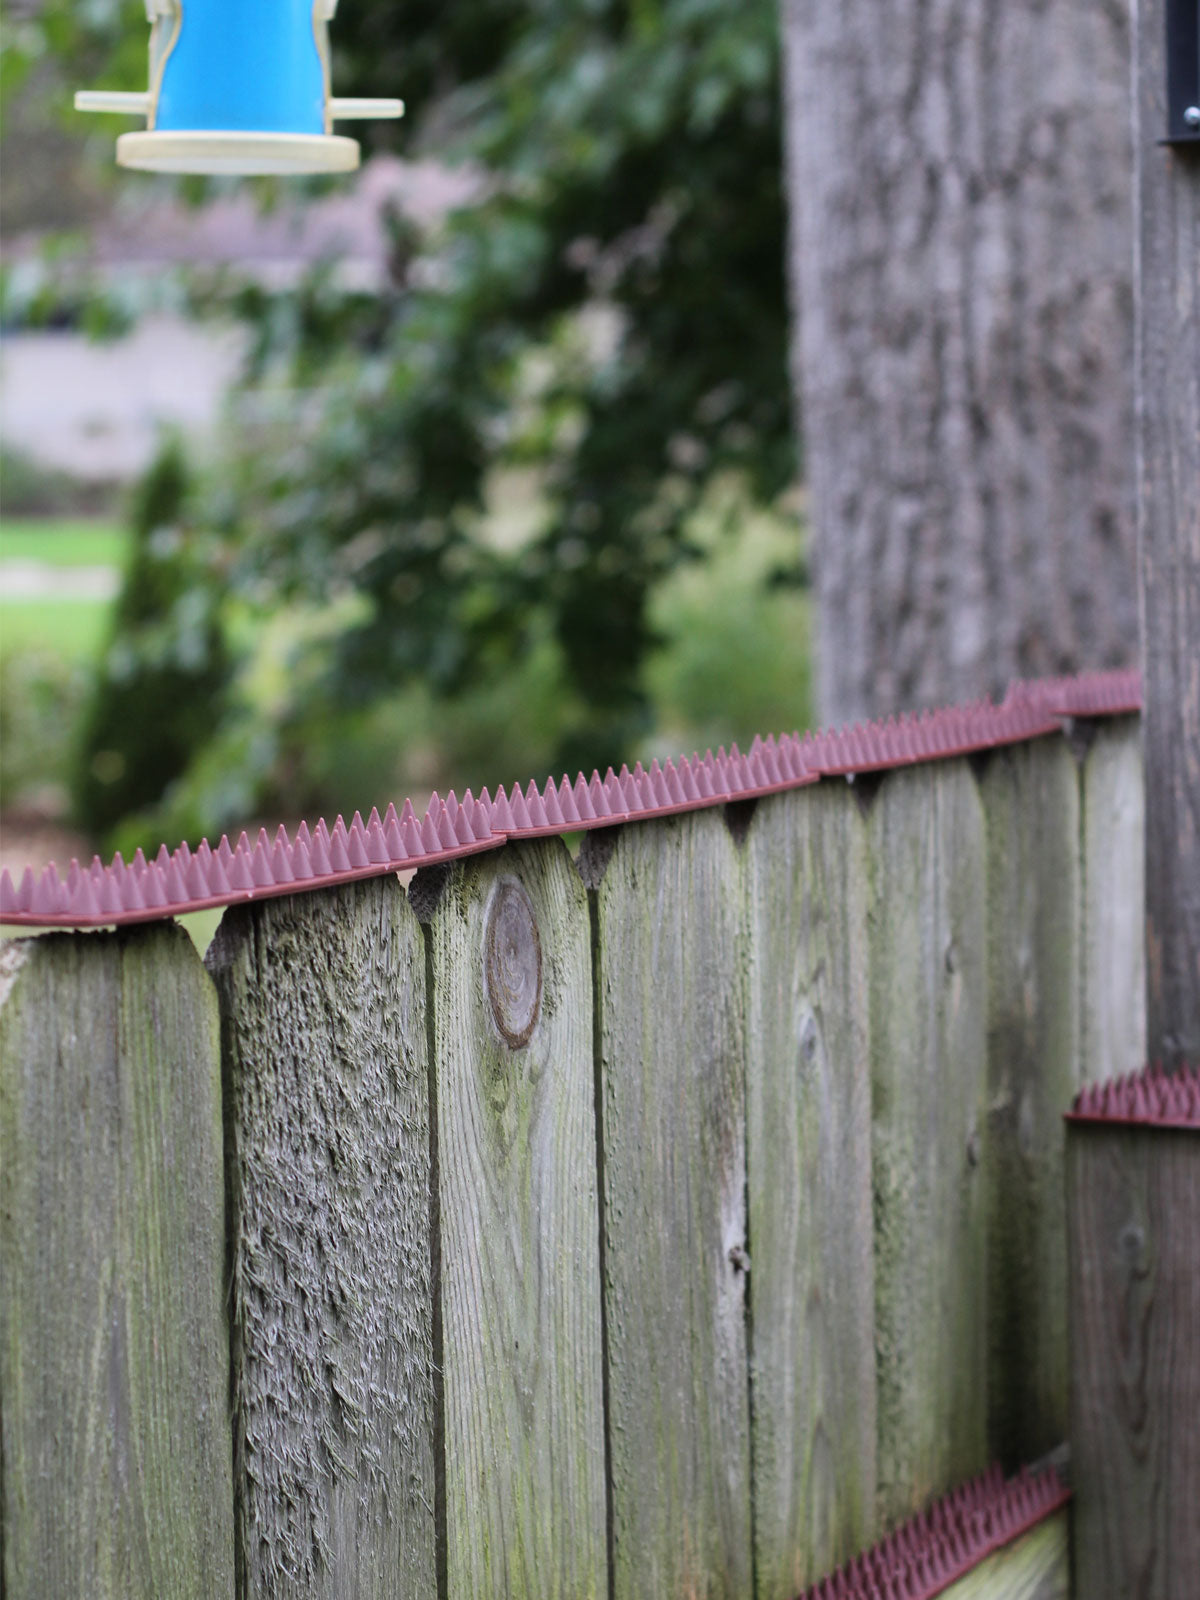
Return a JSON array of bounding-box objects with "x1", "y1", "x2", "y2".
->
[{"x1": 800, "y1": 1467, "x2": 1070, "y2": 1600}]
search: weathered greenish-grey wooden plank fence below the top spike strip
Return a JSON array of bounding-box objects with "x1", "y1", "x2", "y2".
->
[{"x1": 0, "y1": 718, "x2": 1144, "y2": 1600}]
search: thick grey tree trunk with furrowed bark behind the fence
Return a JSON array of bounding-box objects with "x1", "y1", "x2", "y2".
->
[{"x1": 784, "y1": 0, "x2": 1138, "y2": 722}]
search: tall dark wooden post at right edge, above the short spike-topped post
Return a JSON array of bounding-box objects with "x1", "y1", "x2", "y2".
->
[{"x1": 1133, "y1": 0, "x2": 1200, "y2": 1066}]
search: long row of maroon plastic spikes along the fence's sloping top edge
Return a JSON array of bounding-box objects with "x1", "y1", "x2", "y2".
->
[{"x1": 0, "y1": 670, "x2": 1141, "y2": 928}]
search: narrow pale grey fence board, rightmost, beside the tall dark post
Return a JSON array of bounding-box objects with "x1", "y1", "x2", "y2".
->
[{"x1": 1078, "y1": 717, "x2": 1147, "y2": 1083}]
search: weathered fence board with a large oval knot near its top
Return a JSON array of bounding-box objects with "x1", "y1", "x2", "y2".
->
[{"x1": 429, "y1": 838, "x2": 608, "y2": 1600}]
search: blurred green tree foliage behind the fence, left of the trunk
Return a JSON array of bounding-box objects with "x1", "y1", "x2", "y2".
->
[{"x1": 9, "y1": 0, "x2": 803, "y2": 843}]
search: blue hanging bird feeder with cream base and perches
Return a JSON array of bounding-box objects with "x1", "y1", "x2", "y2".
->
[{"x1": 75, "y1": 0, "x2": 405, "y2": 176}]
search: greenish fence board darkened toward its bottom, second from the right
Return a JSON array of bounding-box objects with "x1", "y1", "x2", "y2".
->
[{"x1": 981, "y1": 736, "x2": 1081, "y2": 1470}]
